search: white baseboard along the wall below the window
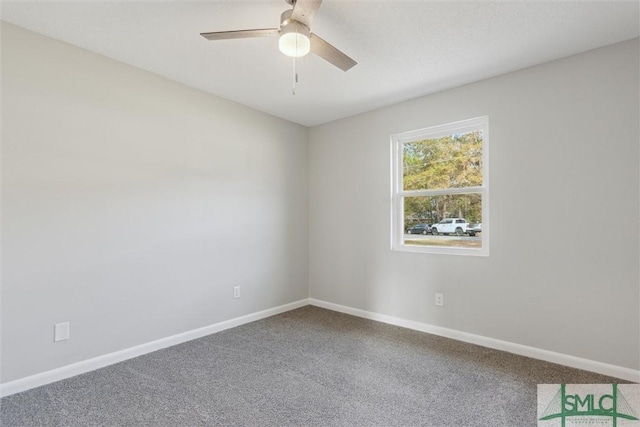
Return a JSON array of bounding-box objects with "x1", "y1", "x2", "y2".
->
[{"x1": 309, "y1": 298, "x2": 640, "y2": 383}]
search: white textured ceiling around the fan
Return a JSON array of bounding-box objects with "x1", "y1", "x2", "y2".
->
[{"x1": 0, "y1": 0, "x2": 639, "y2": 126}]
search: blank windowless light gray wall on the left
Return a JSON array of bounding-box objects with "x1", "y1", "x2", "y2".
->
[{"x1": 1, "y1": 24, "x2": 308, "y2": 382}]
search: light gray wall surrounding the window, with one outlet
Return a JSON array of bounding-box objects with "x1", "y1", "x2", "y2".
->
[{"x1": 309, "y1": 39, "x2": 640, "y2": 369}]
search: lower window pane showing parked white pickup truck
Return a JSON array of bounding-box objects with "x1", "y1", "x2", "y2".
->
[{"x1": 403, "y1": 193, "x2": 482, "y2": 248}]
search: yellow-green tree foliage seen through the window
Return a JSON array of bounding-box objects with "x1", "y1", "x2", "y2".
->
[{"x1": 403, "y1": 132, "x2": 482, "y2": 223}]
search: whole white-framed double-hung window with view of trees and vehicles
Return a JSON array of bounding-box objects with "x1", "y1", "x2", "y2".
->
[{"x1": 391, "y1": 117, "x2": 489, "y2": 255}]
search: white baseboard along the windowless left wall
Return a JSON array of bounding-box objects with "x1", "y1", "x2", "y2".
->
[{"x1": 0, "y1": 299, "x2": 309, "y2": 397}]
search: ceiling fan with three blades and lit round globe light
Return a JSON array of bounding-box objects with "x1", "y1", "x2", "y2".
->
[{"x1": 200, "y1": 0, "x2": 357, "y2": 71}]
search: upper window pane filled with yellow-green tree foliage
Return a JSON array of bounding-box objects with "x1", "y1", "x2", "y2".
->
[{"x1": 402, "y1": 131, "x2": 482, "y2": 191}]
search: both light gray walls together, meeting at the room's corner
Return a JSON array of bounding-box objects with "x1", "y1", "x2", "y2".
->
[{"x1": 0, "y1": 20, "x2": 640, "y2": 388}]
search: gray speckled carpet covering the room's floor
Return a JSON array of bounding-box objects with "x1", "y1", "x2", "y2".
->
[{"x1": 0, "y1": 306, "x2": 624, "y2": 427}]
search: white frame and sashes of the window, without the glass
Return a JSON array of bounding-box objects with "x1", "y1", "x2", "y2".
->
[{"x1": 391, "y1": 116, "x2": 490, "y2": 256}]
